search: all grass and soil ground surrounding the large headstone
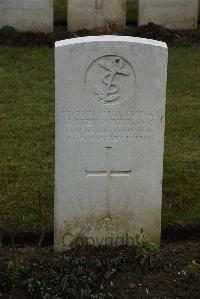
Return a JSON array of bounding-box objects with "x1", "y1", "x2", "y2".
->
[{"x1": 0, "y1": 27, "x2": 200, "y2": 299}]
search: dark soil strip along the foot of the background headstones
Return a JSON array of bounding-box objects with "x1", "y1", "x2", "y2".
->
[{"x1": 0, "y1": 23, "x2": 200, "y2": 47}]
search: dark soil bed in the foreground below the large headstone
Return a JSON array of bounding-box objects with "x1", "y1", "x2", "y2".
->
[{"x1": 0, "y1": 240, "x2": 200, "y2": 299}]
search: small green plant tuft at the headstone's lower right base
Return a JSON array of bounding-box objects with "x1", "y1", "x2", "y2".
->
[{"x1": 135, "y1": 233, "x2": 160, "y2": 266}]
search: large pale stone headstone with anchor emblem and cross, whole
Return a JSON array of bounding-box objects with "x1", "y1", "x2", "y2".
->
[{"x1": 55, "y1": 36, "x2": 167, "y2": 251}]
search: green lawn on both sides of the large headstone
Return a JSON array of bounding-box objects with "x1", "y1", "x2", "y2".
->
[{"x1": 0, "y1": 47, "x2": 200, "y2": 238}]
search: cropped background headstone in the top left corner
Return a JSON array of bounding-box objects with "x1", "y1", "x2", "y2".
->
[{"x1": 0, "y1": 0, "x2": 53, "y2": 32}]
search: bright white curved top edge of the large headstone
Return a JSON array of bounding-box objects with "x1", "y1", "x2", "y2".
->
[{"x1": 55, "y1": 35, "x2": 168, "y2": 49}]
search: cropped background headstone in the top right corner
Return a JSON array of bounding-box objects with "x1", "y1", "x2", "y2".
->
[{"x1": 139, "y1": 0, "x2": 199, "y2": 29}]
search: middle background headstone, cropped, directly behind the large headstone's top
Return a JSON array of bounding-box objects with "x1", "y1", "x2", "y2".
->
[{"x1": 68, "y1": 0, "x2": 126, "y2": 31}]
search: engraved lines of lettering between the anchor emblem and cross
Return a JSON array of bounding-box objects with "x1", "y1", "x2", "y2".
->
[{"x1": 65, "y1": 110, "x2": 158, "y2": 143}]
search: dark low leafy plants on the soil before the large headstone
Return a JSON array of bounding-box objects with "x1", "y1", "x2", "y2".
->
[{"x1": 27, "y1": 256, "x2": 125, "y2": 299}]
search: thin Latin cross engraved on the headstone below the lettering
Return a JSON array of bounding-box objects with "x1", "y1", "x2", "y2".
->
[{"x1": 85, "y1": 147, "x2": 131, "y2": 219}]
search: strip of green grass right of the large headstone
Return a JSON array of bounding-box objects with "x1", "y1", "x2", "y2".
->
[{"x1": 163, "y1": 48, "x2": 200, "y2": 228}]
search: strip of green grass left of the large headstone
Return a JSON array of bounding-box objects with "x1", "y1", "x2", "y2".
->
[{"x1": 0, "y1": 47, "x2": 54, "y2": 231}]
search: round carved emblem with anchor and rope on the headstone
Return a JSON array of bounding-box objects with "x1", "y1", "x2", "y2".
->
[{"x1": 86, "y1": 55, "x2": 135, "y2": 105}]
